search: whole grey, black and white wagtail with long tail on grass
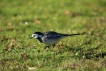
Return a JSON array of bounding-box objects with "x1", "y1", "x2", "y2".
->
[{"x1": 31, "y1": 31, "x2": 84, "y2": 46}]
